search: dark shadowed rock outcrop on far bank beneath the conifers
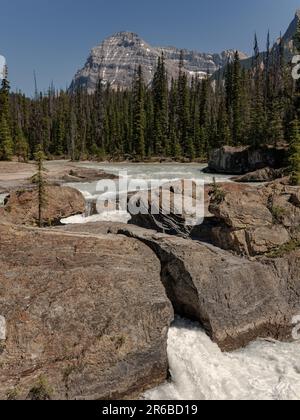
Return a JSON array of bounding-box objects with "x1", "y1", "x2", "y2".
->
[{"x1": 206, "y1": 146, "x2": 288, "y2": 175}]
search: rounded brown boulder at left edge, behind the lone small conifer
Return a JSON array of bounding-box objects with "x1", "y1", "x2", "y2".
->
[{"x1": 0, "y1": 186, "x2": 85, "y2": 226}]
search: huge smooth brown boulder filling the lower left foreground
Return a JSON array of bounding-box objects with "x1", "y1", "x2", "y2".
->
[{"x1": 0, "y1": 224, "x2": 173, "y2": 400}]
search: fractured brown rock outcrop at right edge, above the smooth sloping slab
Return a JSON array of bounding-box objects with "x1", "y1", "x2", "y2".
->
[{"x1": 206, "y1": 182, "x2": 300, "y2": 256}]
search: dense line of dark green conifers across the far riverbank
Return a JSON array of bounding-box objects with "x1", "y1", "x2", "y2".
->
[{"x1": 0, "y1": 28, "x2": 300, "y2": 182}]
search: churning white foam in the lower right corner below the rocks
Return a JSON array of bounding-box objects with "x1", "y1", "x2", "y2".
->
[{"x1": 144, "y1": 318, "x2": 300, "y2": 400}]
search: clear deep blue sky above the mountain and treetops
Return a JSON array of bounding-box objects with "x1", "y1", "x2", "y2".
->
[{"x1": 0, "y1": 0, "x2": 300, "y2": 95}]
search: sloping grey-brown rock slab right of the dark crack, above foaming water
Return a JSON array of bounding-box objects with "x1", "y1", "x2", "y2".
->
[{"x1": 60, "y1": 223, "x2": 300, "y2": 351}]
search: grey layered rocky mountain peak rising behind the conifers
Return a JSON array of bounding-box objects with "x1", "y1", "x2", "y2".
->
[{"x1": 70, "y1": 32, "x2": 247, "y2": 92}]
